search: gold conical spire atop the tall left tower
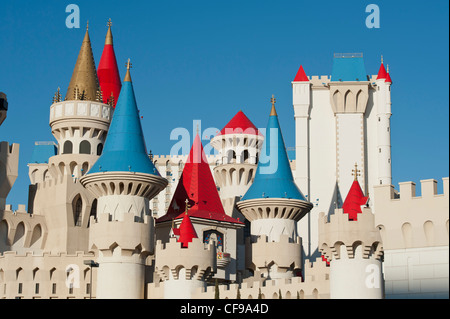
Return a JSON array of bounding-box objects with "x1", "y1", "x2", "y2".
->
[{"x1": 66, "y1": 25, "x2": 100, "y2": 101}]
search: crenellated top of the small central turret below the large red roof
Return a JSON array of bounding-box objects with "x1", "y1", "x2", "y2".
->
[{"x1": 155, "y1": 238, "x2": 217, "y2": 281}]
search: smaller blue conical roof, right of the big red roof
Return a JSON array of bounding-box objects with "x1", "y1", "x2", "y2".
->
[{"x1": 242, "y1": 106, "x2": 306, "y2": 200}]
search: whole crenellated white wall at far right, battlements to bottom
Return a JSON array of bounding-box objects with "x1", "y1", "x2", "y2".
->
[{"x1": 374, "y1": 177, "x2": 449, "y2": 298}]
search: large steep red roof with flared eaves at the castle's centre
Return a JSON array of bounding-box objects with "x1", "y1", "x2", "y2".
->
[{"x1": 156, "y1": 134, "x2": 242, "y2": 224}]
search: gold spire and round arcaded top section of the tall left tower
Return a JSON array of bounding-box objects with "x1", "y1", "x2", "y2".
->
[{"x1": 49, "y1": 25, "x2": 113, "y2": 178}]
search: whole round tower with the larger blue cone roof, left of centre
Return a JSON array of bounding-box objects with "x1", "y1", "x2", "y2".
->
[{"x1": 80, "y1": 61, "x2": 167, "y2": 299}]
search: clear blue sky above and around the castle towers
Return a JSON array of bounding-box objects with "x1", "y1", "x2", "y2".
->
[{"x1": 0, "y1": 0, "x2": 449, "y2": 208}]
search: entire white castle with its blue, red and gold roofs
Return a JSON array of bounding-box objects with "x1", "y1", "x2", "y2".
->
[{"x1": 0, "y1": 21, "x2": 449, "y2": 299}]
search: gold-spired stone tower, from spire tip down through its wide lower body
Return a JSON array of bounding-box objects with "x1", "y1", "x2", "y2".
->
[{"x1": 29, "y1": 26, "x2": 113, "y2": 253}]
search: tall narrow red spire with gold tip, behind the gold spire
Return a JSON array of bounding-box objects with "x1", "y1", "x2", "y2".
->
[{"x1": 97, "y1": 23, "x2": 122, "y2": 107}]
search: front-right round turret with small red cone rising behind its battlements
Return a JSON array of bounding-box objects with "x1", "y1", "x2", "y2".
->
[{"x1": 319, "y1": 169, "x2": 384, "y2": 299}]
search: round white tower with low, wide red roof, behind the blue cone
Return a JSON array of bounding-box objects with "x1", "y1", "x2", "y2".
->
[{"x1": 211, "y1": 111, "x2": 264, "y2": 218}]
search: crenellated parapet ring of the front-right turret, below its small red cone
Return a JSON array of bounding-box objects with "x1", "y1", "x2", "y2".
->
[{"x1": 319, "y1": 208, "x2": 383, "y2": 260}]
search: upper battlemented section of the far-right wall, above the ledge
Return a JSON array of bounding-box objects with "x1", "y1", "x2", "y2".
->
[{"x1": 373, "y1": 177, "x2": 449, "y2": 249}]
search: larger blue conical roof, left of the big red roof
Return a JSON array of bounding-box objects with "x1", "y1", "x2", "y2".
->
[{"x1": 88, "y1": 70, "x2": 160, "y2": 176}]
